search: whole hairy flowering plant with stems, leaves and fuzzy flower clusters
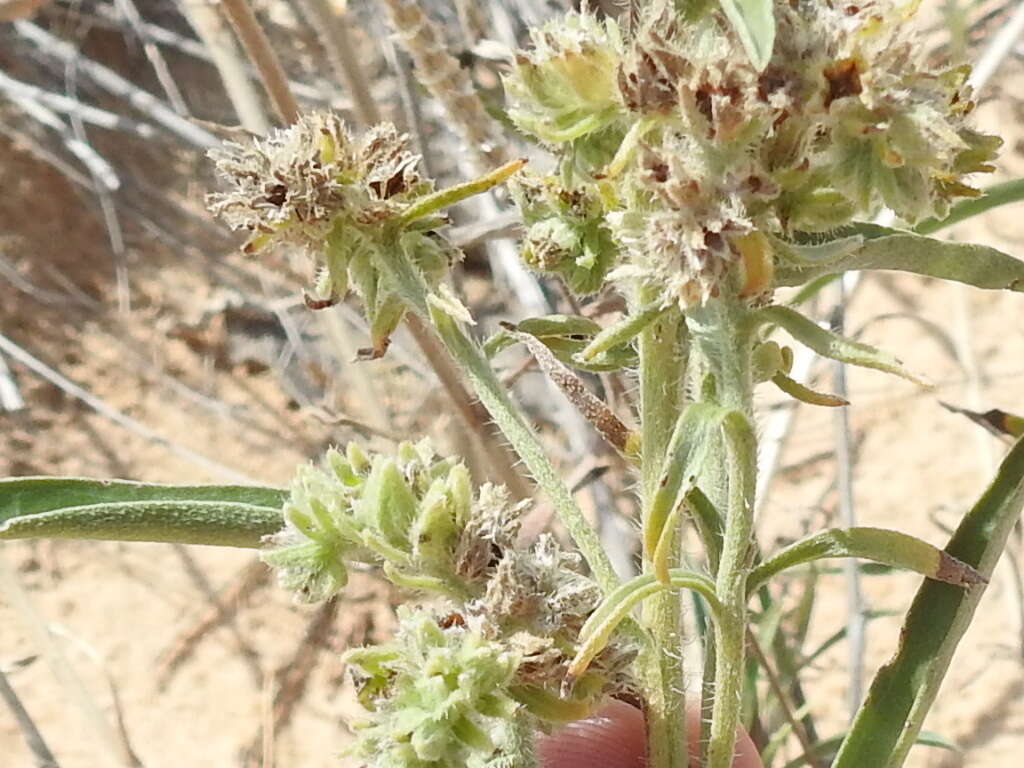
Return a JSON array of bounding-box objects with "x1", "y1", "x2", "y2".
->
[{"x1": 0, "y1": 0, "x2": 1024, "y2": 768}]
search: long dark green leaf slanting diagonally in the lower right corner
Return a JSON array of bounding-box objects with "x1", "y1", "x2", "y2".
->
[{"x1": 834, "y1": 439, "x2": 1024, "y2": 768}]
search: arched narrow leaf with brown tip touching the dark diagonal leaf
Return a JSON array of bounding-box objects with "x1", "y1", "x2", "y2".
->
[{"x1": 746, "y1": 527, "x2": 984, "y2": 593}]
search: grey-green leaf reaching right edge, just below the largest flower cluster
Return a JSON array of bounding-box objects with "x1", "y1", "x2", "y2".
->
[{"x1": 775, "y1": 223, "x2": 1024, "y2": 291}]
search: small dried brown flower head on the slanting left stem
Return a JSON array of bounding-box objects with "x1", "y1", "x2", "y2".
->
[{"x1": 207, "y1": 113, "x2": 457, "y2": 357}]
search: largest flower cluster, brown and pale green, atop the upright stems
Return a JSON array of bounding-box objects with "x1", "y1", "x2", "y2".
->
[{"x1": 506, "y1": 0, "x2": 999, "y2": 308}]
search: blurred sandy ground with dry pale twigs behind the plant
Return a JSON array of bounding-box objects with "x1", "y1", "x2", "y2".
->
[{"x1": 0, "y1": 0, "x2": 1024, "y2": 768}]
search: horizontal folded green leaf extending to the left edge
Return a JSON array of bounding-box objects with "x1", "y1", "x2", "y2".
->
[{"x1": 0, "y1": 477, "x2": 287, "y2": 547}]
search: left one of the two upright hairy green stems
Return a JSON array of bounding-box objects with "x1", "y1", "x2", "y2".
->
[{"x1": 637, "y1": 297, "x2": 689, "y2": 768}]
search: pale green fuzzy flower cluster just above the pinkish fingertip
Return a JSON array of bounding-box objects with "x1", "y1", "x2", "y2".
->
[{"x1": 263, "y1": 440, "x2": 635, "y2": 768}]
